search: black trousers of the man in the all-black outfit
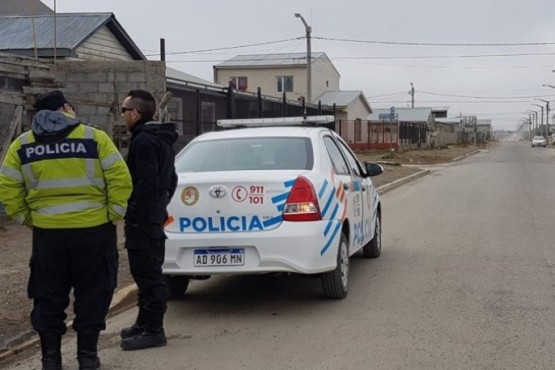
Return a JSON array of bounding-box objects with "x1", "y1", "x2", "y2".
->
[{"x1": 125, "y1": 223, "x2": 167, "y2": 328}]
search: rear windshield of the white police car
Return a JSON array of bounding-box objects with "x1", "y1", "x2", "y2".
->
[{"x1": 175, "y1": 137, "x2": 313, "y2": 173}]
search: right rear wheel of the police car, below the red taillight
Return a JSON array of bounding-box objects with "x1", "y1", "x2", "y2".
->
[{"x1": 322, "y1": 233, "x2": 349, "y2": 299}]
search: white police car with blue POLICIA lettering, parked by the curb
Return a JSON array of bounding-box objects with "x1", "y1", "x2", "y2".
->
[{"x1": 163, "y1": 116, "x2": 383, "y2": 299}]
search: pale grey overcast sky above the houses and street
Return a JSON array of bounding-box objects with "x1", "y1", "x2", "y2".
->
[{"x1": 43, "y1": 0, "x2": 555, "y2": 129}]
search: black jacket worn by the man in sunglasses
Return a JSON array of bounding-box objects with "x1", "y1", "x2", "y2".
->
[{"x1": 125, "y1": 122, "x2": 178, "y2": 225}]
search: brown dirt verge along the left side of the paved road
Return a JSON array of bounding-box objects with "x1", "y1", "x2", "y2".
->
[{"x1": 0, "y1": 145, "x2": 483, "y2": 353}]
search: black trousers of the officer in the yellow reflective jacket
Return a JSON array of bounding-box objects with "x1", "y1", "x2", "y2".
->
[{"x1": 27, "y1": 222, "x2": 118, "y2": 335}]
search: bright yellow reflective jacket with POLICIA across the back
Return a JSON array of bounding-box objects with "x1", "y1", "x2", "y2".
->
[{"x1": 0, "y1": 124, "x2": 132, "y2": 229}]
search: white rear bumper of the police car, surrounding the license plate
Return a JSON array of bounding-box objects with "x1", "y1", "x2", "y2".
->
[{"x1": 162, "y1": 220, "x2": 341, "y2": 275}]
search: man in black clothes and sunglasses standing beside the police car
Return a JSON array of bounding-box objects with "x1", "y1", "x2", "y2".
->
[{"x1": 121, "y1": 90, "x2": 177, "y2": 350}]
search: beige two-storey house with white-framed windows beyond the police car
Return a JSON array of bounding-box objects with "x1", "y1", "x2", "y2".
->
[{"x1": 213, "y1": 52, "x2": 340, "y2": 103}]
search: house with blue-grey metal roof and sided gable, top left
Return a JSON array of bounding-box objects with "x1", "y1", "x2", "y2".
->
[{"x1": 0, "y1": 13, "x2": 146, "y2": 60}]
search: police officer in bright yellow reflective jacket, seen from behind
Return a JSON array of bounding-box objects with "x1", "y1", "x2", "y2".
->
[{"x1": 0, "y1": 91, "x2": 132, "y2": 370}]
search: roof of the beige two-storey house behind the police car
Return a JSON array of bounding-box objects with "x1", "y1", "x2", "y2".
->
[{"x1": 216, "y1": 52, "x2": 329, "y2": 68}]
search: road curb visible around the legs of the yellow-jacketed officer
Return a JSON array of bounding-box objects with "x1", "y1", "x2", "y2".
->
[{"x1": 0, "y1": 284, "x2": 137, "y2": 362}]
